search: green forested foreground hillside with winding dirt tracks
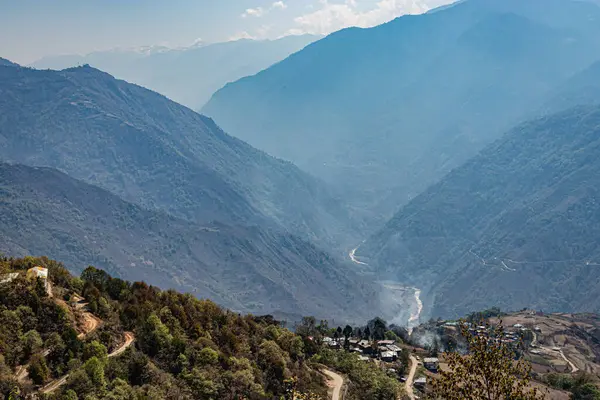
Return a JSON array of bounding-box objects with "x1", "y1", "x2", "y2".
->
[{"x1": 0, "y1": 257, "x2": 399, "y2": 400}]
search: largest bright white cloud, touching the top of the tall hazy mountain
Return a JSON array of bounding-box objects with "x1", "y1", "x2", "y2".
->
[{"x1": 287, "y1": 0, "x2": 453, "y2": 35}]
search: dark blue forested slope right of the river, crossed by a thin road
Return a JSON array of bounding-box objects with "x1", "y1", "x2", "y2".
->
[{"x1": 356, "y1": 107, "x2": 600, "y2": 316}]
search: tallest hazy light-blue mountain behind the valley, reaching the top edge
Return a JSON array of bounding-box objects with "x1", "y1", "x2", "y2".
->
[{"x1": 203, "y1": 0, "x2": 600, "y2": 218}]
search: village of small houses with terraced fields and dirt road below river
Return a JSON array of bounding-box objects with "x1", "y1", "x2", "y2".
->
[{"x1": 323, "y1": 310, "x2": 600, "y2": 400}]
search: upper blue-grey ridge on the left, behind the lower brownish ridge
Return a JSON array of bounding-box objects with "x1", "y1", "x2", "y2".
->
[{"x1": 0, "y1": 66, "x2": 353, "y2": 244}]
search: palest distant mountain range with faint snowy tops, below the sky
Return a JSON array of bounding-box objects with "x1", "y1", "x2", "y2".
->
[{"x1": 31, "y1": 35, "x2": 318, "y2": 110}]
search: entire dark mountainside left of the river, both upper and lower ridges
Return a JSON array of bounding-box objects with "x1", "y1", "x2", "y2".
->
[{"x1": 0, "y1": 62, "x2": 375, "y2": 317}]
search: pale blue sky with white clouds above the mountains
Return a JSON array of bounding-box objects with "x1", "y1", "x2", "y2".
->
[{"x1": 0, "y1": 0, "x2": 451, "y2": 65}]
